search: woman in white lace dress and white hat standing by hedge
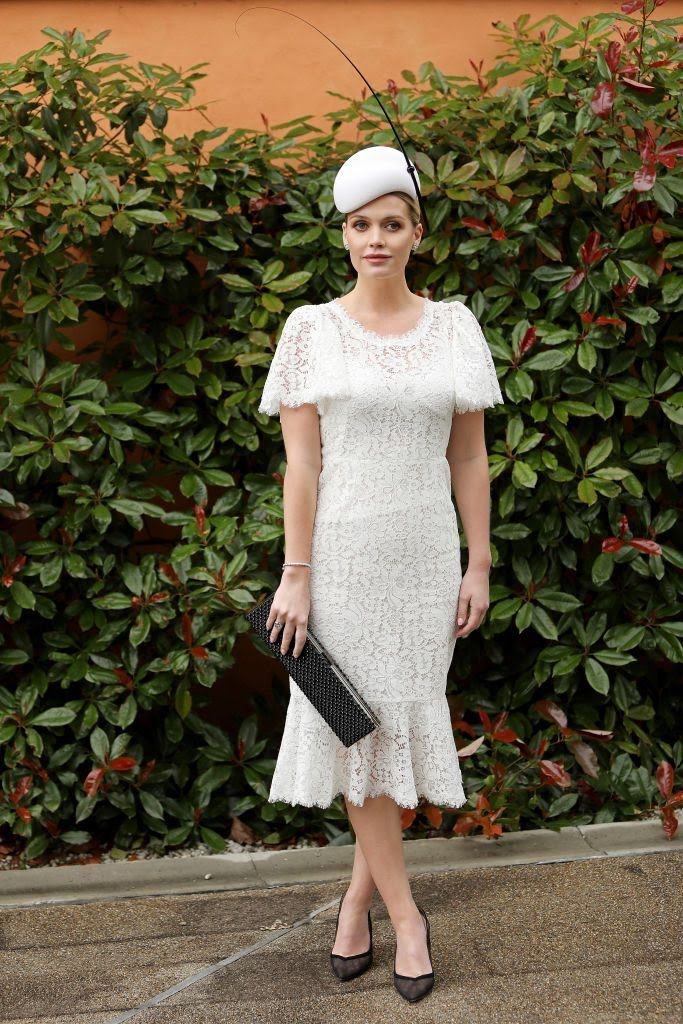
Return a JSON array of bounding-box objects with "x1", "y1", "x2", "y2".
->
[{"x1": 259, "y1": 146, "x2": 503, "y2": 1001}]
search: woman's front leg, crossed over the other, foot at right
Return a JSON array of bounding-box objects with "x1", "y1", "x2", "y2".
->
[{"x1": 339, "y1": 797, "x2": 431, "y2": 977}]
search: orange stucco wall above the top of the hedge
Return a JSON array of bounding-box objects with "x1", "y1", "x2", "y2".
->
[{"x1": 0, "y1": 0, "x2": 683, "y2": 133}]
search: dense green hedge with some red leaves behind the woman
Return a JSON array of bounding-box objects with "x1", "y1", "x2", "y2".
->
[{"x1": 0, "y1": 9, "x2": 683, "y2": 859}]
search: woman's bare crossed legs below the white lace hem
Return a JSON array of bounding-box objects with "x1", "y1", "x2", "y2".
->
[{"x1": 333, "y1": 797, "x2": 431, "y2": 977}]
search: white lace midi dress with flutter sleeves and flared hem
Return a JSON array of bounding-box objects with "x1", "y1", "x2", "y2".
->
[{"x1": 259, "y1": 299, "x2": 503, "y2": 807}]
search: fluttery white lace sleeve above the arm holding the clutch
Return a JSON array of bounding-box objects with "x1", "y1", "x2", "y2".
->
[{"x1": 258, "y1": 305, "x2": 316, "y2": 416}]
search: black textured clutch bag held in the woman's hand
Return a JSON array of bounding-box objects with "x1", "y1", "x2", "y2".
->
[{"x1": 246, "y1": 592, "x2": 380, "y2": 746}]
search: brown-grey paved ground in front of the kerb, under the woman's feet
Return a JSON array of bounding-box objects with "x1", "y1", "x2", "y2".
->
[{"x1": 0, "y1": 840, "x2": 683, "y2": 1024}]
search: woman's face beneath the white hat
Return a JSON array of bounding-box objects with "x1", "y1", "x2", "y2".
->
[{"x1": 342, "y1": 196, "x2": 422, "y2": 276}]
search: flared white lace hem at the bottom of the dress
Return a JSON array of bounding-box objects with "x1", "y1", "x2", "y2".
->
[{"x1": 268, "y1": 692, "x2": 467, "y2": 808}]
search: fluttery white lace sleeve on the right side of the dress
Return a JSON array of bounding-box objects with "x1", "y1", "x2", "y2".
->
[{"x1": 452, "y1": 301, "x2": 504, "y2": 413}]
